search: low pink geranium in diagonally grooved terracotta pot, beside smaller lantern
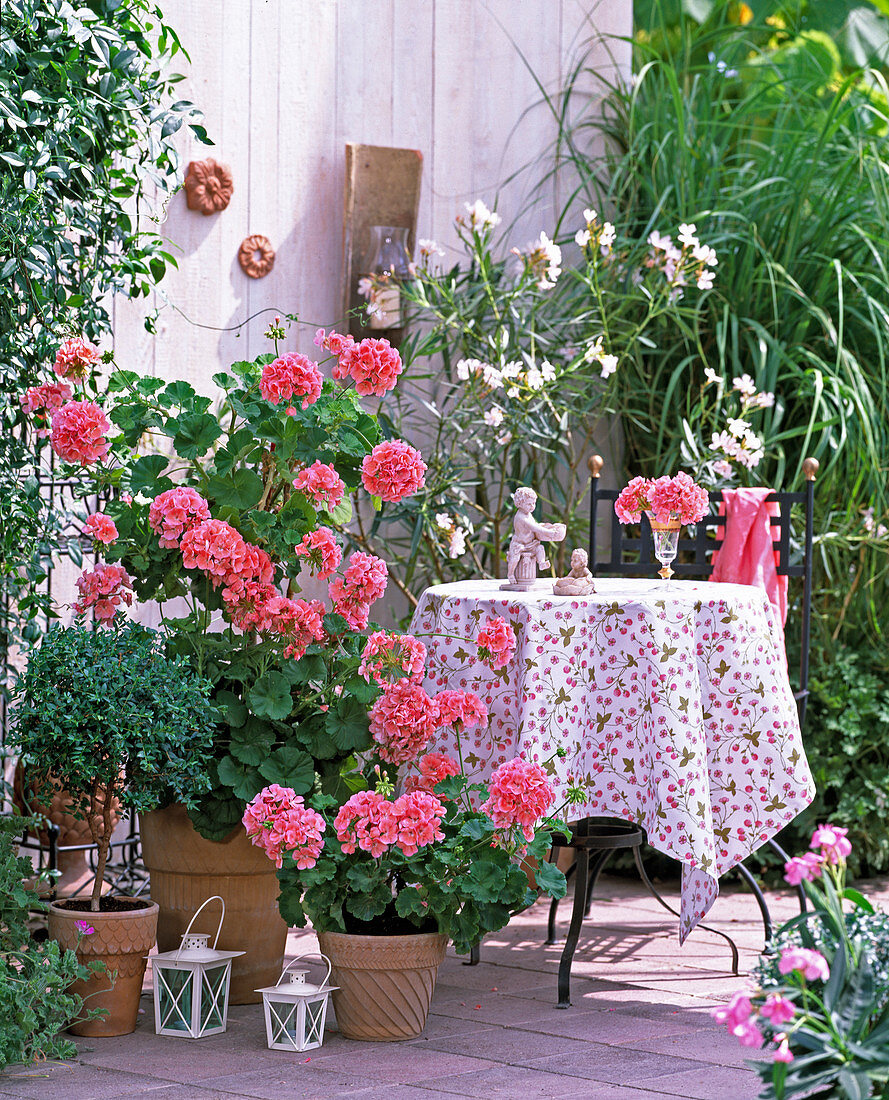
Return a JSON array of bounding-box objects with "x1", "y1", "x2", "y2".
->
[{"x1": 244, "y1": 633, "x2": 566, "y2": 1041}]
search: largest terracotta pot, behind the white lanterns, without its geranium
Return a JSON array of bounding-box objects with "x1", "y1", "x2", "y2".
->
[{"x1": 140, "y1": 805, "x2": 287, "y2": 1004}]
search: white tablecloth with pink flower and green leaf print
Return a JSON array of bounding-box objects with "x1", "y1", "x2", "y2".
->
[{"x1": 411, "y1": 578, "x2": 814, "y2": 941}]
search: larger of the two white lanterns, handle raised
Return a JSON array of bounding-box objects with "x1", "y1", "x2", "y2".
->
[{"x1": 149, "y1": 894, "x2": 245, "y2": 1038}]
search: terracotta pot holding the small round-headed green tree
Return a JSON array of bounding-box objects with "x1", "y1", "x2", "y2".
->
[{"x1": 48, "y1": 898, "x2": 157, "y2": 1037}]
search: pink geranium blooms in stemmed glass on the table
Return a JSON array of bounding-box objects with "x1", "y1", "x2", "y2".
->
[{"x1": 614, "y1": 472, "x2": 710, "y2": 581}]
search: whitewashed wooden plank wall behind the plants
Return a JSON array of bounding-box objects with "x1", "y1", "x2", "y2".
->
[{"x1": 114, "y1": 0, "x2": 633, "y2": 385}]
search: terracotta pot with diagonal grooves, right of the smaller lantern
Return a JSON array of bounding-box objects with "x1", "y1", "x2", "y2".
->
[{"x1": 318, "y1": 932, "x2": 448, "y2": 1043}]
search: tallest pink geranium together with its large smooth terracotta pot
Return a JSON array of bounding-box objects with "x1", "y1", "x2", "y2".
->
[{"x1": 16, "y1": 323, "x2": 426, "y2": 1003}]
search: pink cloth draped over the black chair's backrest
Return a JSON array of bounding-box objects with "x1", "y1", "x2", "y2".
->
[{"x1": 712, "y1": 487, "x2": 787, "y2": 628}]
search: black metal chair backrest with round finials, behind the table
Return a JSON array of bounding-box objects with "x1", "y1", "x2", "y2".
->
[{"x1": 588, "y1": 454, "x2": 819, "y2": 723}]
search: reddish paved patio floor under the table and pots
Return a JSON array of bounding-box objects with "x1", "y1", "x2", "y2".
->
[{"x1": 6, "y1": 878, "x2": 889, "y2": 1100}]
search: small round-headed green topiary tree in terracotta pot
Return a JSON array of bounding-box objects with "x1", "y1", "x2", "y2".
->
[{"x1": 11, "y1": 620, "x2": 212, "y2": 1035}]
